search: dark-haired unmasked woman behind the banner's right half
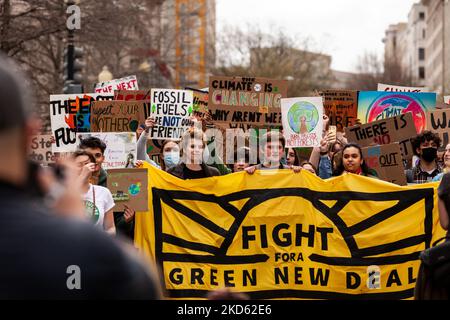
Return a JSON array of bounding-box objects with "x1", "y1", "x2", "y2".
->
[{"x1": 333, "y1": 143, "x2": 377, "y2": 177}]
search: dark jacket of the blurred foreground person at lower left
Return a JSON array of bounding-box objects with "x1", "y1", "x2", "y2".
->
[{"x1": 0, "y1": 181, "x2": 159, "y2": 299}]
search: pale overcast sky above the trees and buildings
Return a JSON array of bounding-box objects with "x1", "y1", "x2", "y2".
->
[{"x1": 216, "y1": 0, "x2": 419, "y2": 71}]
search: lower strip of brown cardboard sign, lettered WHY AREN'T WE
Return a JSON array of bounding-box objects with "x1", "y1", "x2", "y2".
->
[{"x1": 210, "y1": 106, "x2": 281, "y2": 130}]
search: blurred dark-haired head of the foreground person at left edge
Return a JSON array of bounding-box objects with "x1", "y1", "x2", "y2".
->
[{"x1": 0, "y1": 53, "x2": 40, "y2": 185}]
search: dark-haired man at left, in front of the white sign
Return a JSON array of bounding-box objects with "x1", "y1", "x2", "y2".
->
[{"x1": 78, "y1": 136, "x2": 108, "y2": 188}]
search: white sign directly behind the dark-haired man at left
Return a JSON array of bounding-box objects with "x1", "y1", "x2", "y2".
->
[{"x1": 77, "y1": 132, "x2": 137, "y2": 170}]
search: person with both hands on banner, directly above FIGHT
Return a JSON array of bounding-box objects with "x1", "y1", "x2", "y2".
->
[{"x1": 245, "y1": 131, "x2": 302, "y2": 174}]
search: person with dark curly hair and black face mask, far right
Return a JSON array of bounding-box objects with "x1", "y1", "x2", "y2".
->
[{"x1": 405, "y1": 131, "x2": 442, "y2": 183}]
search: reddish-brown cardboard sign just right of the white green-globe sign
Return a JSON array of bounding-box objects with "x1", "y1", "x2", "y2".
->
[{"x1": 319, "y1": 90, "x2": 358, "y2": 132}]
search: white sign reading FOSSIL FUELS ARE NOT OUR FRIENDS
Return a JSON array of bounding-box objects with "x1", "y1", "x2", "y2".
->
[{"x1": 150, "y1": 89, "x2": 194, "y2": 140}]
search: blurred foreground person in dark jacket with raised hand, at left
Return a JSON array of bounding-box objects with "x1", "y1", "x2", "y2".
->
[{"x1": 0, "y1": 55, "x2": 161, "y2": 300}]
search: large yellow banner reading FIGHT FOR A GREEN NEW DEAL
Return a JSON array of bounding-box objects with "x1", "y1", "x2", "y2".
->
[{"x1": 135, "y1": 166, "x2": 444, "y2": 299}]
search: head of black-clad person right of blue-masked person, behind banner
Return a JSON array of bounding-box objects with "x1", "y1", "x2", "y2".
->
[{"x1": 181, "y1": 127, "x2": 206, "y2": 164}]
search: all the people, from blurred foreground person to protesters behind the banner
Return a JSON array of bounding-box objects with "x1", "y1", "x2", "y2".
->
[{"x1": 0, "y1": 51, "x2": 450, "y2": 299}]
